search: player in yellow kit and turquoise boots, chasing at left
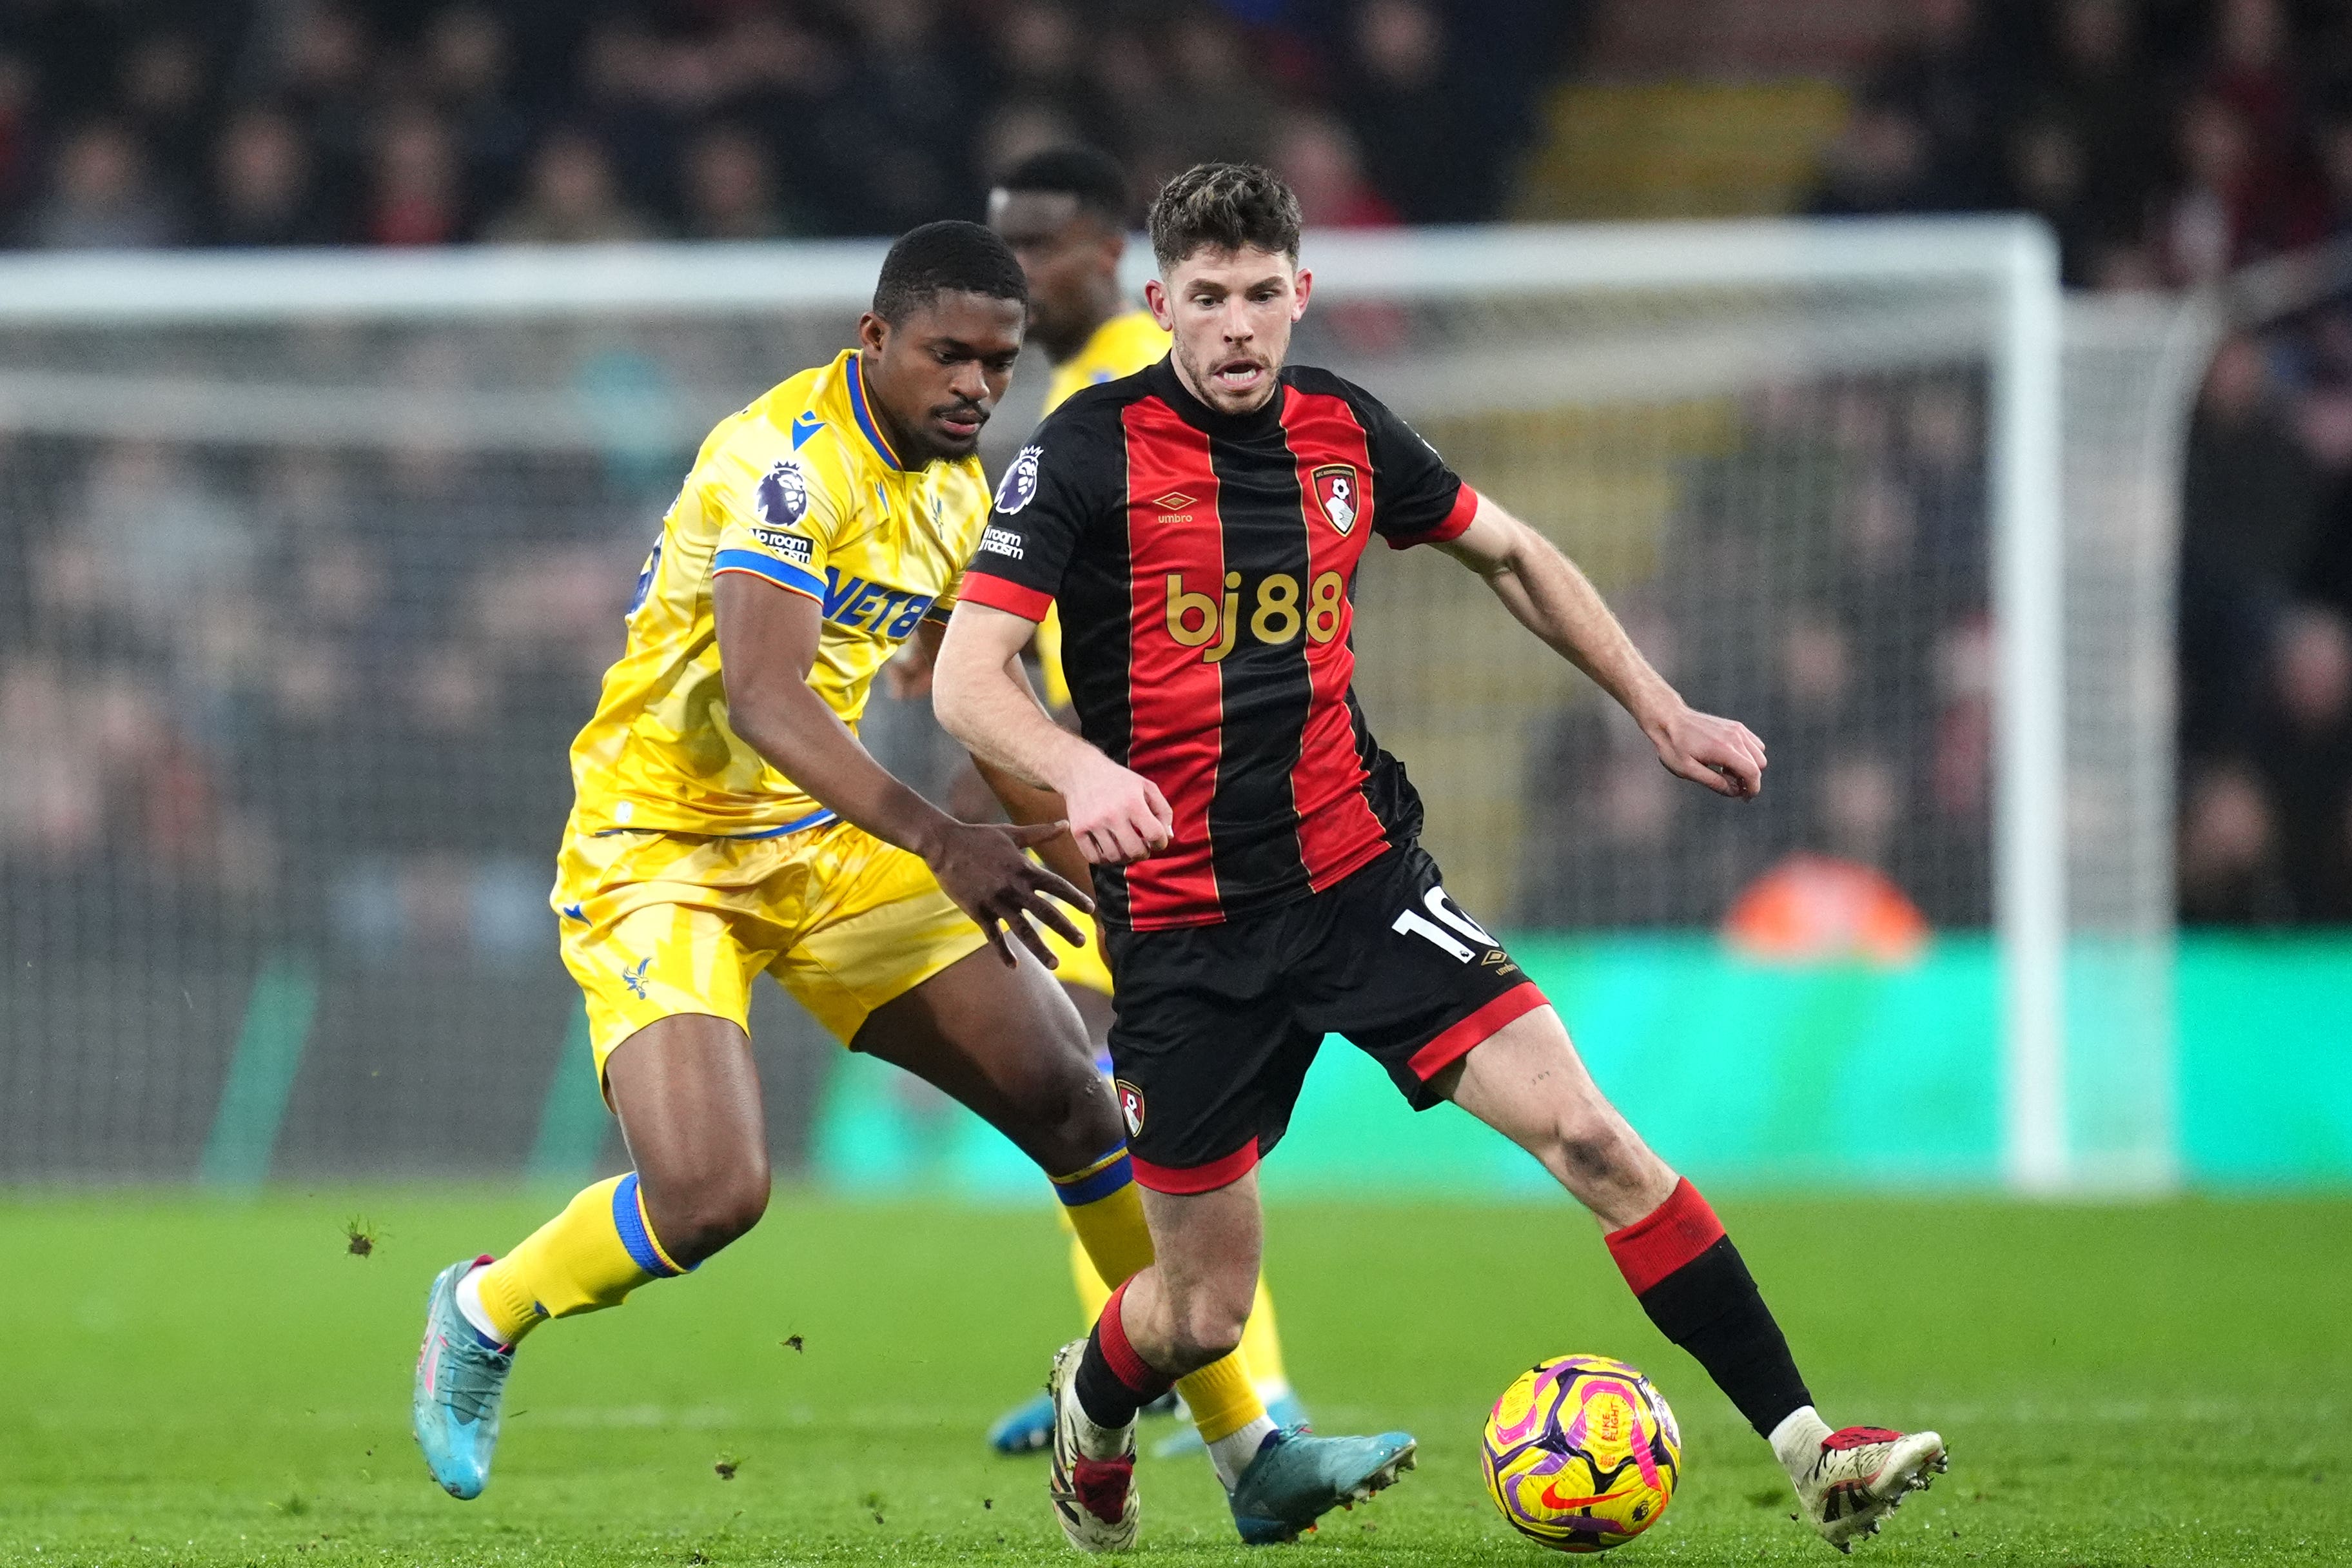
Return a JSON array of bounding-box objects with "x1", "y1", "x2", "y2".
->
[{"x1": 411, "y1": 223, "x2": 1346, "y2": 1524}]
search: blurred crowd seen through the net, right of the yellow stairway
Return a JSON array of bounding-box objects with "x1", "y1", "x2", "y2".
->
[{"x1": 1517, "y1": 371, "x2": 1992, "y2": 940}]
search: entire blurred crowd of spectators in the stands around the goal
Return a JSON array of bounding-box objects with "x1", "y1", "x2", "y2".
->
[{"x1": 0, "y1": 0, "x2": 2352, "y2": 952}]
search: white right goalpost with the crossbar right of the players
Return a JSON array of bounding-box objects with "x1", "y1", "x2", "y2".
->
[{"x1": 1306, "y1": 216, "x2": 2075, "y2": 1192}]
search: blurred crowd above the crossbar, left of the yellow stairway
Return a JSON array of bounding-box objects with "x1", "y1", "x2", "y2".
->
[{"x1": 0, "y1": 0, "x2": 1578, "y2": 247}]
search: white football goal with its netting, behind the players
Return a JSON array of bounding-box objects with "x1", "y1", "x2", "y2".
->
[{"x1": 0, "y1": 221, "x2": 2202, "y2": 1185}]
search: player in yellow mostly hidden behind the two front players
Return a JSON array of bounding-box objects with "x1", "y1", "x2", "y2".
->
[{"x1": 981, "y1": 146, "x2": 1308, "y2": 1453}]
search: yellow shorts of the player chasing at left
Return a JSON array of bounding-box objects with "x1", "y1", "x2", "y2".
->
[{"x1": 551, "y1": 823, "x2": 986, "y2": 1081}]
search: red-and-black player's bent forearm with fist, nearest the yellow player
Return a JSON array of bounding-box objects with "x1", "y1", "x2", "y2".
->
[{"x1": 932, "y1": 600, "x2": 1176, "y2": 865}]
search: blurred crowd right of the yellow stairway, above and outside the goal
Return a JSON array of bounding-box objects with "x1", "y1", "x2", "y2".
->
[{"x1": 1814, "y1": 0, "x2": 2352, "y2": 924}]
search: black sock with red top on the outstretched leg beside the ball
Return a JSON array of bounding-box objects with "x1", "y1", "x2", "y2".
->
[{"x1": 1609, "y1": 1182, "x2": 1814, "y2": 1436}]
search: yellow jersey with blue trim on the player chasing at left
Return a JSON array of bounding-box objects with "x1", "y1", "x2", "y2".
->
[{"x1": 571, "y1": 350, "x2": 988, "y2": 837}]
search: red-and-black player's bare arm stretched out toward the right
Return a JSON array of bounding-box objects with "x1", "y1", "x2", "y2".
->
[{"x1": 1440, "y1": 496, "x2": 1764, "y2": 797}]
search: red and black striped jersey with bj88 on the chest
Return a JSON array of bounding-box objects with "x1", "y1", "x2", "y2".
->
[{"x1": 962, "y1": 360, "x2": 1477, "y2": 931}]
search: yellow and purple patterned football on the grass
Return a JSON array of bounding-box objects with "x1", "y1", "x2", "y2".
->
[{"x1": 1480, "y1": 1357, "x2": 1681, "y2": 1551}]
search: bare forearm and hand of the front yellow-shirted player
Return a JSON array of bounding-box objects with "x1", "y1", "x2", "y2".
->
[{"x1": 710, "y1": 571, "x2": 1093, "y2": 968}]
